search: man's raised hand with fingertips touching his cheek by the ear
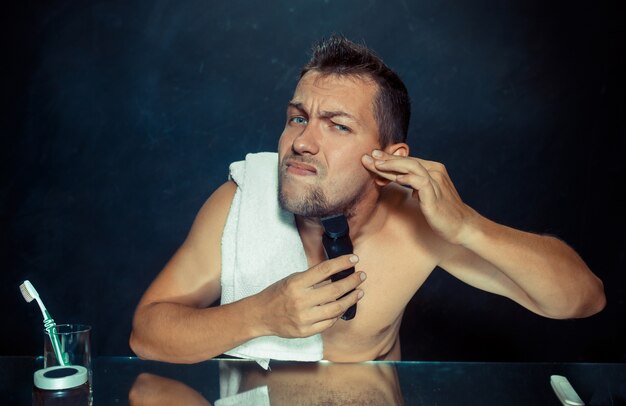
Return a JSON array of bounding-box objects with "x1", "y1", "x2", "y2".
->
[{"x1": 362, "y1": 150, "x2": 477, "y2": 244}]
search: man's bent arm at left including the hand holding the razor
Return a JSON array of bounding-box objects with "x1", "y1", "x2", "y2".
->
[{"x1": 130, "y1": 182, "x2": 365, "y2": 363}]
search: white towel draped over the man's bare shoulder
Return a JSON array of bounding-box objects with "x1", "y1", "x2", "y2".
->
[{"x1": 221, "y1": 152, "x2": 324, "y2": 369}]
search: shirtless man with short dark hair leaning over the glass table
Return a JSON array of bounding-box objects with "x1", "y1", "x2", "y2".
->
[{"x1": 130, "y1": 37, "x2": 605, "y2": 362}]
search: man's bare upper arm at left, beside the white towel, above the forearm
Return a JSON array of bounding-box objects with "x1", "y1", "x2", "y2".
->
[{"x1": 139, "y1": 181, "x2": 237, "y2": 307}]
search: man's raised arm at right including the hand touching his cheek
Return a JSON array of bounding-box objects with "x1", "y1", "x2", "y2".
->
[{"x1": 363, "y1": 153, "x2": 605, "y2": 318}]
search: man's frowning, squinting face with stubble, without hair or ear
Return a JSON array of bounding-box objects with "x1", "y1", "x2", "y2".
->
[{"x1": 278, "y1": 71, "x2": 380, "y2": 217}]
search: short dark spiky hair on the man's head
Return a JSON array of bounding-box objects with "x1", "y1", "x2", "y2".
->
[{"x1": 300, "y1": 35, "x2": 411, "y2": 147}]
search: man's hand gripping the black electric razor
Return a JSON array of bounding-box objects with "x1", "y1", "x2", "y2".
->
[{"x1": 254, "y1": 255, "x2": 365, "y2": 338}]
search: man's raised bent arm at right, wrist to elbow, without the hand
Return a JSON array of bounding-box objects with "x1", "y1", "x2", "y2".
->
[{"x1": 440, "y1": 214, "x2": 605, "y2": 319}]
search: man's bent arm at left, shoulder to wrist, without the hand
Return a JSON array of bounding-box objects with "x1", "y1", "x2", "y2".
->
[{"x1": 130, "y1": 182, "x2": 255, "y2": 362}]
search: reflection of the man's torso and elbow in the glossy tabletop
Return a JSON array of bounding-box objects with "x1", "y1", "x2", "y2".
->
[{"x1": 129, "y1": 361, "x2": 404, "y2": 406}]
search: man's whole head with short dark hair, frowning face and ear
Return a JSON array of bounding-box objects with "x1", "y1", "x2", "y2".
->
[{"x1": 278, "y1": 37, "x2": 409, "y2": 217}]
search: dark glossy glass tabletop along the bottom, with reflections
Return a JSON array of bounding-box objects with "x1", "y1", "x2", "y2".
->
[{"x1": 0, "y1": 357, "x2": 626, "y2": 406}]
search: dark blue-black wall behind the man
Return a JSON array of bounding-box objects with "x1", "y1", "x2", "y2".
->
[{"x1": 0, "y1": 0, "x2": 626, "y2": 362}]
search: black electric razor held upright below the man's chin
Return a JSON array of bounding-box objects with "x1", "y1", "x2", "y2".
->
[{"x1": 321, "y1": 214, "x2": 356, "y2": 320}]
